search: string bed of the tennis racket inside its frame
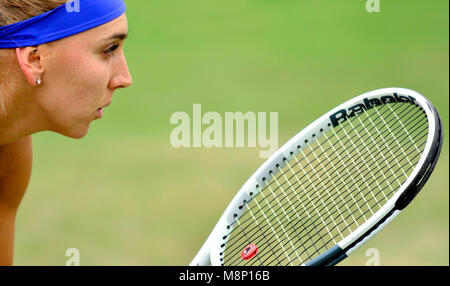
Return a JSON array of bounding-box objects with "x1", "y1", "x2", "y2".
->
[{"x1": 225, "y1": 101, "x2": 427, "y2": 265}]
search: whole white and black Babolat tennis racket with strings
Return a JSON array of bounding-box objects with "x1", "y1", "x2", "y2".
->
[{"x1": 190, "y1": 88, "x2": 443, "y2": 266}]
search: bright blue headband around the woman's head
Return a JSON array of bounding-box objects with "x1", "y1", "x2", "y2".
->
[{"x1": 0, "y1": 0, "x2": 126, "y2": 49}]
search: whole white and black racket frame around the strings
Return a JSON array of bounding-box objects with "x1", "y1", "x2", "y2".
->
[{"x1": 190, "y1": 88, "x2": 443, "y2": 266}]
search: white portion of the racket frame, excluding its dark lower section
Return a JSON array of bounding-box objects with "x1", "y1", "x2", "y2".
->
[{"x1": 190, "y1": 87, "x2": 442, "y2": 266}]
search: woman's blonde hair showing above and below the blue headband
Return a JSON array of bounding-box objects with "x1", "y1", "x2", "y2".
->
[{"x1": 0, "y1": 0, "x2": 67, "y2": 115}]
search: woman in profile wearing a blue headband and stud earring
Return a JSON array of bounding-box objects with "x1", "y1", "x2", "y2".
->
[{"x1": 0, "y1": 0, "x2": 132, "y2": 265}]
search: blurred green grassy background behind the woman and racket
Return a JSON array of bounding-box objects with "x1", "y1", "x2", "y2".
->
[{"x1": 15, "y1": 0, "x2": 449, "y2": 265}]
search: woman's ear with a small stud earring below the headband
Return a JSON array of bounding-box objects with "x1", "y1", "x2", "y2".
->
[{"x1": 16, "y1": 46, "x2": 44, "y2": 86}]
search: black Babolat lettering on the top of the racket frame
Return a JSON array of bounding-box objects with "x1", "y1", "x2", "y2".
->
[{"x1": 330, "y1": 93, "x2": 416, "y2": 127}]
